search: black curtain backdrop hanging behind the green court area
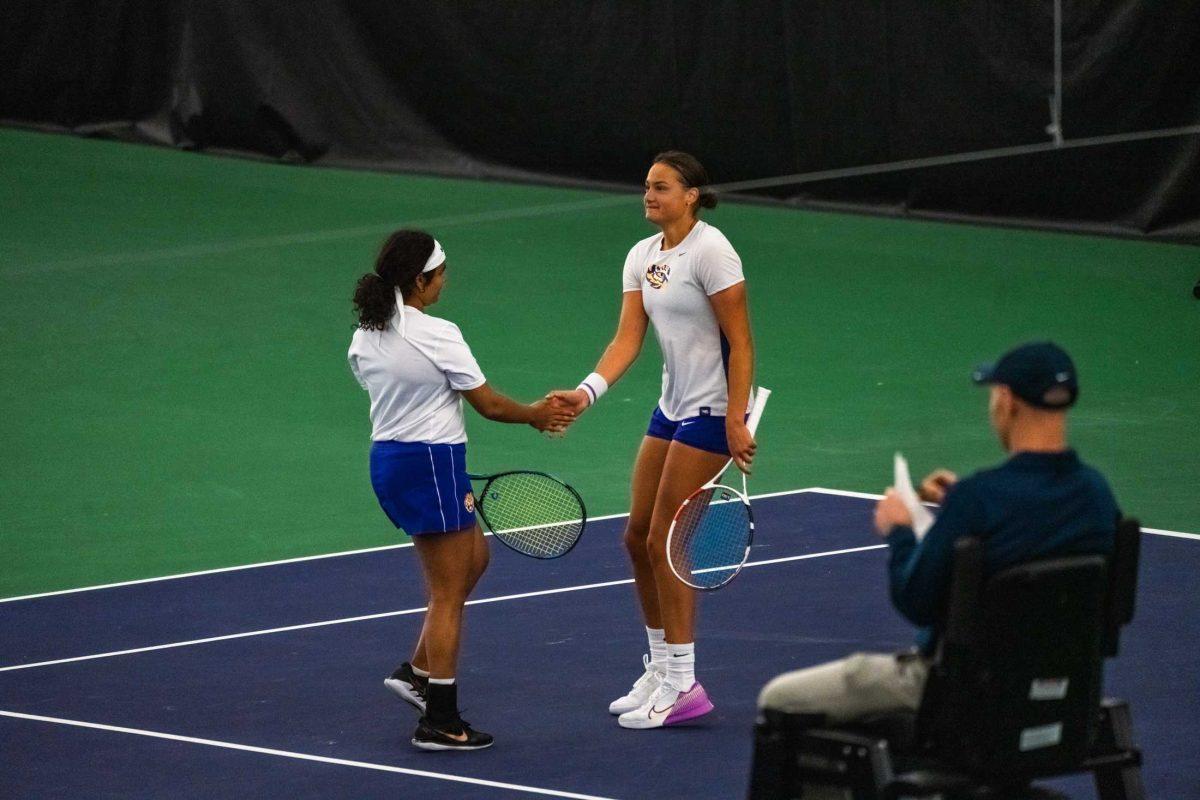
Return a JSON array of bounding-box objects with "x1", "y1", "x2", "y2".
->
[{"x1": 0, "y1": 0, "x2": 1200, "y2": 243}]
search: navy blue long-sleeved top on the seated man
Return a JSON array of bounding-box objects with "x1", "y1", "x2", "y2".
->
[{"x1": 888, "y1": 450, "x2": 1118, "y2": 654}]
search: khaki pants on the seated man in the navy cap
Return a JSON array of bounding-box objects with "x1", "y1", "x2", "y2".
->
[{"x1": 758, "y1": 652, "x2": 929, "y2": 724}]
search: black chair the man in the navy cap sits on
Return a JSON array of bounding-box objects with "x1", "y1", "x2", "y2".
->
[{"x1": 749, "y1": 519, "x2": 1145, "y2": 800}]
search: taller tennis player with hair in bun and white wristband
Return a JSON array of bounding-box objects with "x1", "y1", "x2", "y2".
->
[{"x1": 551, "y1": 151, "x2": 755, "y2": 728}]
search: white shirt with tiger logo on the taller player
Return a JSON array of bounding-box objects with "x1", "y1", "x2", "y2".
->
[{"x1": 623, "y1": 221, "x2": 745, "y2": 422}]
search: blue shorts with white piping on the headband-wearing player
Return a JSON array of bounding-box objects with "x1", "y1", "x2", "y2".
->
[{"x1": 371, "y1": 441, "x2": 475, "y2": 536}]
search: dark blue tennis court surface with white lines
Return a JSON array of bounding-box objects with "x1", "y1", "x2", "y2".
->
[{"x1": 0, "y1": 489, "x2": 1200, "y2": 800}]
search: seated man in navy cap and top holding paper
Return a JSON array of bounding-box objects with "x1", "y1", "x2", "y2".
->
[{"x1": 758, "y1": 342, "x2": 1118, "y2": 724}]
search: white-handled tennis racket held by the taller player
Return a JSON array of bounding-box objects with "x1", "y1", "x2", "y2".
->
[{"x1": 667, "y1": 386, "x2": 770, "y2": 590}]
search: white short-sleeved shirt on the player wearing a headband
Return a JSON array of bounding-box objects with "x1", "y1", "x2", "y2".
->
[{"x1": 347, "y1": 300, "x2": 486, "y2": 444}]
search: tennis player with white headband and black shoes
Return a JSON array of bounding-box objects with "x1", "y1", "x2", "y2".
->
[{"x1": 348, "y1": 230, "x2": 574, "y2": 750}]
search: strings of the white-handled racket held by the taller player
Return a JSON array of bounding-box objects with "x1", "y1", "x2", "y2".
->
[{"x1": 668, "y1": 486, "x2": 754, "y2": 589}]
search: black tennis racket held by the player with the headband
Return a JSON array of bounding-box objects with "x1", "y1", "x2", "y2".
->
[{"x1": 468, "y1": 470, "x2": 588, "y2": 559}]
